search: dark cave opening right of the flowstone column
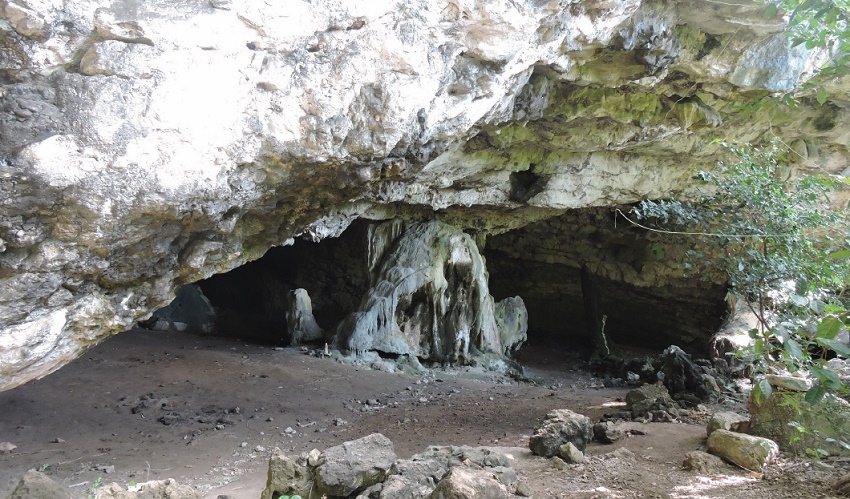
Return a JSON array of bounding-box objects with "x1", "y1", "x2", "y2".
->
[{"x1": 483, "y1": 208, "x2": 727, "y2": 356}]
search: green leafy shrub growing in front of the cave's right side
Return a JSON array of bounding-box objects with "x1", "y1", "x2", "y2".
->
[{"x1": 633, "y1": 144, "x2": 850, "y2": 403}]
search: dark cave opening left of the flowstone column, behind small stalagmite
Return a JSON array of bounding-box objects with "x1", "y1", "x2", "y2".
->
[{"x1": 155, "y1": 221, "x2": 368, "y2": 345}]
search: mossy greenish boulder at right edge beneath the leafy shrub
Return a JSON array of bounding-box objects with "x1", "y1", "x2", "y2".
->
[{"x1": 748, "y1": 376, "x2": 850, "y2": 456}]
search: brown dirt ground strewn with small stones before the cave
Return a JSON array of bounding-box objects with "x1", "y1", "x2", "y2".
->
[{"x1": 0, "y1": 330, "x2": 850, "y2": 499}]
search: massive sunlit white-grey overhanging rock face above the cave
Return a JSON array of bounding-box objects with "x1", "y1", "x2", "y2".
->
[{"x1": 0, "y1": 0, "x2": 848, "y2": 389}]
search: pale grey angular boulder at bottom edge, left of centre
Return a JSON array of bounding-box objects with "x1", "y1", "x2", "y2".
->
[{"x1": 315, "y1": 433, "x2": 397, "y2": 496}]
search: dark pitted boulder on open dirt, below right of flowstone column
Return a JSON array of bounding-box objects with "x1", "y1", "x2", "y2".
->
[{"x1": 528, "y1": 409, "x2": 593, "y2": 457}]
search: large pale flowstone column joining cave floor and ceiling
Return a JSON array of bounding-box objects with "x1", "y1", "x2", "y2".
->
[{"x1": 335, "y1": 221, "x2": 527, "y2": 364}]
